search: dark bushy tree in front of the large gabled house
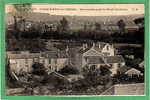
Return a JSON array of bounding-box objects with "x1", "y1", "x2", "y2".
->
[{"x1": 83, "y1": 65, "x2": 111, "y2": 85}]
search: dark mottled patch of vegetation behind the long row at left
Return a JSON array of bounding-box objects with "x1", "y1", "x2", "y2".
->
[{"x1": 6, "y1": 39, "x2": 47, "y2": 52}]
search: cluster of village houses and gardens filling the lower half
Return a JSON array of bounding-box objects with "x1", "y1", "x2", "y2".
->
[{"x1": 7, "y1": 41, "x2": 144, "y2": 95}]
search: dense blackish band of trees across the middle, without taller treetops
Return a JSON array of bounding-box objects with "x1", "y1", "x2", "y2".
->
[{"x1": 8, "y1": 29, "x2": 144, "y2": 44}]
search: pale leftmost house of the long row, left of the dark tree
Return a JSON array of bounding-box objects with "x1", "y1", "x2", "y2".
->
[{"x1": 7, "y1": 51, "x2": 40, "y2": 74}]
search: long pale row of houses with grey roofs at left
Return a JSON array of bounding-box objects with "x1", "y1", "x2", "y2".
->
[{"x1": 7, "y1": 51, "x2": 68, "y2": 74}]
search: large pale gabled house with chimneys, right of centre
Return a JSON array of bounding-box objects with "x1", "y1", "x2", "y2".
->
[{"x1": 75, "y1": 43, "x2": 125, "y2": 75}]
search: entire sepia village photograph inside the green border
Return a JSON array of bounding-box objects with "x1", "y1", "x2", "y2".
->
[{"x1": 5, "y1": 3, "x2": 145, "y2": 96}]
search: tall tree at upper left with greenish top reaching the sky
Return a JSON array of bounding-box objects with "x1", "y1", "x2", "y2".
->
[{"x1": 12, "y1": 4, "x2": 32, "y2": 39}]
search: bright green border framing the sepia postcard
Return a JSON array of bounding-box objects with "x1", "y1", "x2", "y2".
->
[{"x1": 0, "y1": 0, "x2": 150, "y2": 100}]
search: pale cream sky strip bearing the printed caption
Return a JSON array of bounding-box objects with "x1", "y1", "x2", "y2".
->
[{"x1": 5, "y1": 4, "x2": 144, "y2": 16}]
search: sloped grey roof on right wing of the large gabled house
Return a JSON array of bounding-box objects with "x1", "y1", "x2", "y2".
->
[{"x1": 104, "y1": 55, "x2": 125, "y2": 64}]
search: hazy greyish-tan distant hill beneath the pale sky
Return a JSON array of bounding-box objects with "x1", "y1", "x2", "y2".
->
[{"x1": 6, "y1": 13, "x2": 144, "y2": 25}]
